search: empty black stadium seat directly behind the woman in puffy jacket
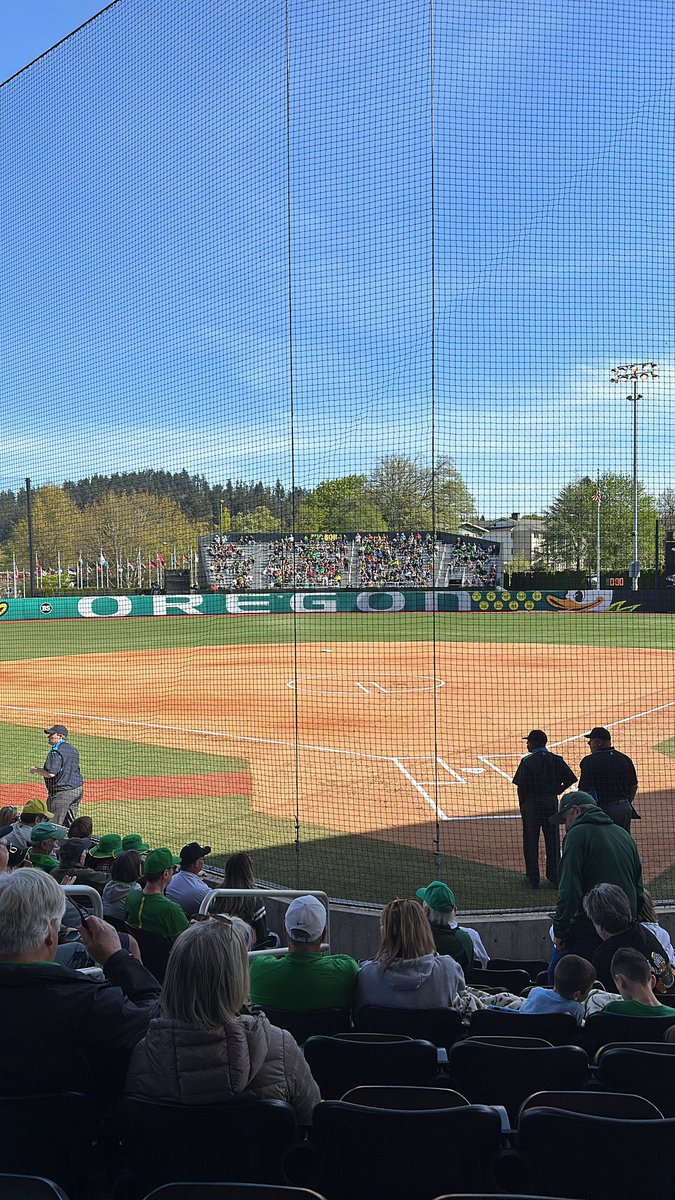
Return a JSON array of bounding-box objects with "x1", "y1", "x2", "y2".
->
[{"x1": 109, "y1": 1096, "x2": 295, "y2": 1192}]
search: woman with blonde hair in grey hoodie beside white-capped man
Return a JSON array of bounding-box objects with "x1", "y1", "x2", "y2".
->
[{"x1": 354, "y1": 900, "x2": 465, "y2": 1009}]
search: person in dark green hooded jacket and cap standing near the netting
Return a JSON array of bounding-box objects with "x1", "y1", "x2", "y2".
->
[{"x1": 549, "y1": 792, "x2": 644, "y2": 976}]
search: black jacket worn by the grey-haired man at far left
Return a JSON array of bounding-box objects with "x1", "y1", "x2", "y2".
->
[{"x1": 0, "y1": 950, "x2": 160, "y2": 1096}]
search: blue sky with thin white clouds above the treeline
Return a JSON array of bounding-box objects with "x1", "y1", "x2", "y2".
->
[{"x1": 0, "y1": 0, "x2": 675, "y2": 516}]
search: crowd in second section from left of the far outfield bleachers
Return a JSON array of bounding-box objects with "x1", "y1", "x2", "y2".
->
[{"x1": 264, "y1": 533, "x2": 352, "y2": 588}]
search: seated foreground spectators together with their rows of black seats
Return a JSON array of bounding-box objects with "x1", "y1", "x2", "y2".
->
[{"x1": 0, "y1": 799, "x2": 675, "y2": 1200}]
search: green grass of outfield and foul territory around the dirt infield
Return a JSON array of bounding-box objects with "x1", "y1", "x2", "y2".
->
[{"x1": 0, "y1": 613, "x2": 675, "y2": 910}]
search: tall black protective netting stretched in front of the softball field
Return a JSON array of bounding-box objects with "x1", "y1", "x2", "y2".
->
[{"x1": 0, "y1": 0, "x2": 675, "y2": 908}]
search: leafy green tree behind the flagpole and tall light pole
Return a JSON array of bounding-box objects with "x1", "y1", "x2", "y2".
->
[{"x1": 546, "y1": 472, "x2": 658, "y2": 574}]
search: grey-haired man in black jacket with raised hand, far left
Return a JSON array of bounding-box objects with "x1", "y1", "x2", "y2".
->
[{"x1": 0, "y1": 870, "x2": 160, "y2": 1096}]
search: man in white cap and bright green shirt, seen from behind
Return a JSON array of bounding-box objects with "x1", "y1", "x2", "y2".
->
[{"x1": 251, "y1": 895, "x2": 359, "y2": 1012}]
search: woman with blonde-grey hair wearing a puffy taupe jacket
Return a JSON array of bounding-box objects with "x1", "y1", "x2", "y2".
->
[{"x1": 126, "y1": 916, "x2": 321, "y2": 1126}]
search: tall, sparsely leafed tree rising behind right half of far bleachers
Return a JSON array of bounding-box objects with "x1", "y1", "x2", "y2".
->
[{"x1": 370, "y1": 455, "x2": 476, "y2": 530}]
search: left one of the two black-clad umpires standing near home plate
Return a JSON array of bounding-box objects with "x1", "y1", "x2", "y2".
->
[{"x1": 513, "y1": 730, "x2": 577, "y2": 888}]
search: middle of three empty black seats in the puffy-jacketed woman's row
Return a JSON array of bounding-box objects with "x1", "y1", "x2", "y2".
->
[{"x1": 448, "y1": 1038, "x2": 589, "y2": 1126}]
